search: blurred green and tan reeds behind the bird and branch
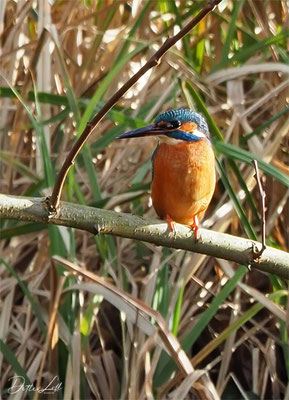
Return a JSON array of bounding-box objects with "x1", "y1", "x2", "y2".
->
[{"x1": 0, "y1": 0, "x2": 289, "y2": 399}]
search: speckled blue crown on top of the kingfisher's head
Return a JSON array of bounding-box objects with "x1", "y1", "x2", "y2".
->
[{"x1": 154, "y1": 108, "x2": 209, "y2": 136}]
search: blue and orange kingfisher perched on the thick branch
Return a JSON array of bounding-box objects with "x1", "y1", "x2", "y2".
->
[{"x1": 117, "y1": 108, "x2": 216, "y2": 239}]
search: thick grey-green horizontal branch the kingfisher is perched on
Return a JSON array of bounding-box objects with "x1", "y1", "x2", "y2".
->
[{"x1": 0, "y1": 194, "x2": 289, "y2": 279}]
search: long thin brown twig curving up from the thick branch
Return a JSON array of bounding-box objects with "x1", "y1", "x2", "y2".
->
[{"x1": 47, "y1": 0, "x2": 222, "y2": 212}]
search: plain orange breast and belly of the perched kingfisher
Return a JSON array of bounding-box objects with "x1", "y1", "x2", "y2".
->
[{"x1": 152, "y1": 139, "x2": 216, "y2": 225}]
